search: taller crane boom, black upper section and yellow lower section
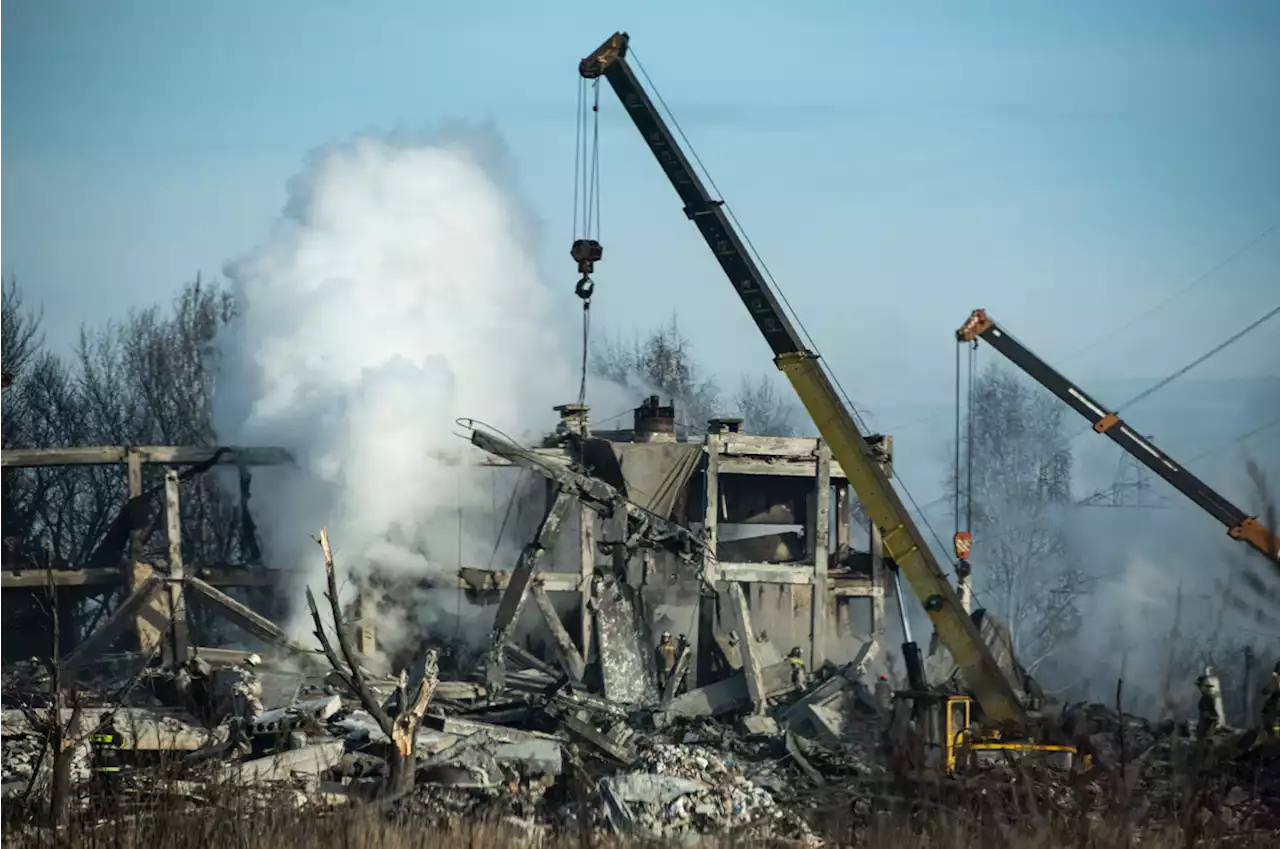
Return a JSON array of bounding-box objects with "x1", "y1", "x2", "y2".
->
[{"x1": 579, "y1": 32, "x2": 1027, "y2": 724}]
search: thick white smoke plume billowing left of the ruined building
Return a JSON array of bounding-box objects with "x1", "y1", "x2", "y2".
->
[{"x1": 215, "y1": 132, "x2": 579, "y2": 637}]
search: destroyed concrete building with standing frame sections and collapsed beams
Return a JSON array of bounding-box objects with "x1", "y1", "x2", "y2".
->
[{"x1": 0, "y1": 398, "x2": 890, "y2": 845}]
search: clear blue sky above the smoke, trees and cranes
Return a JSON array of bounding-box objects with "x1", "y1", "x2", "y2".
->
[{"x1": 0, "y1": 0, "x2": 1280, "y2": 501}]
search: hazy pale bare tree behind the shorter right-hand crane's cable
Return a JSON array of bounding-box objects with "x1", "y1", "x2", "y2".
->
[{"x1": 947, "y1": 364, "x2": 1092, "y2": 672}]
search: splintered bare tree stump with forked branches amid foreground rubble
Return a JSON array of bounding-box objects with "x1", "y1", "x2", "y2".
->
[{"x1": 307, "y1": 529, "x2": 438, "y2": 798}]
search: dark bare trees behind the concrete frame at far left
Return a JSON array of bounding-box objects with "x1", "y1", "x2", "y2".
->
[{"x1": 0, "y1": 277, "x2": 237, "y2": 578}]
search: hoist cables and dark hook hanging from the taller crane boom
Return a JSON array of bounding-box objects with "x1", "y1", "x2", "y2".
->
[{"x1": 570, "y1": 78, "x2": 603, "y2": 405}]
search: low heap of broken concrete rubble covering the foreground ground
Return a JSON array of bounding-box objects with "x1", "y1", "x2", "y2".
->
[{"x1": 0, "y1": 645, "x2": 1280, "y2": 845}]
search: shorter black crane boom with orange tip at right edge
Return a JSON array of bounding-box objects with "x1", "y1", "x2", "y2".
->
[{"x1": 956, "y1": 310, "x2": 1280, "y2": 561}]
